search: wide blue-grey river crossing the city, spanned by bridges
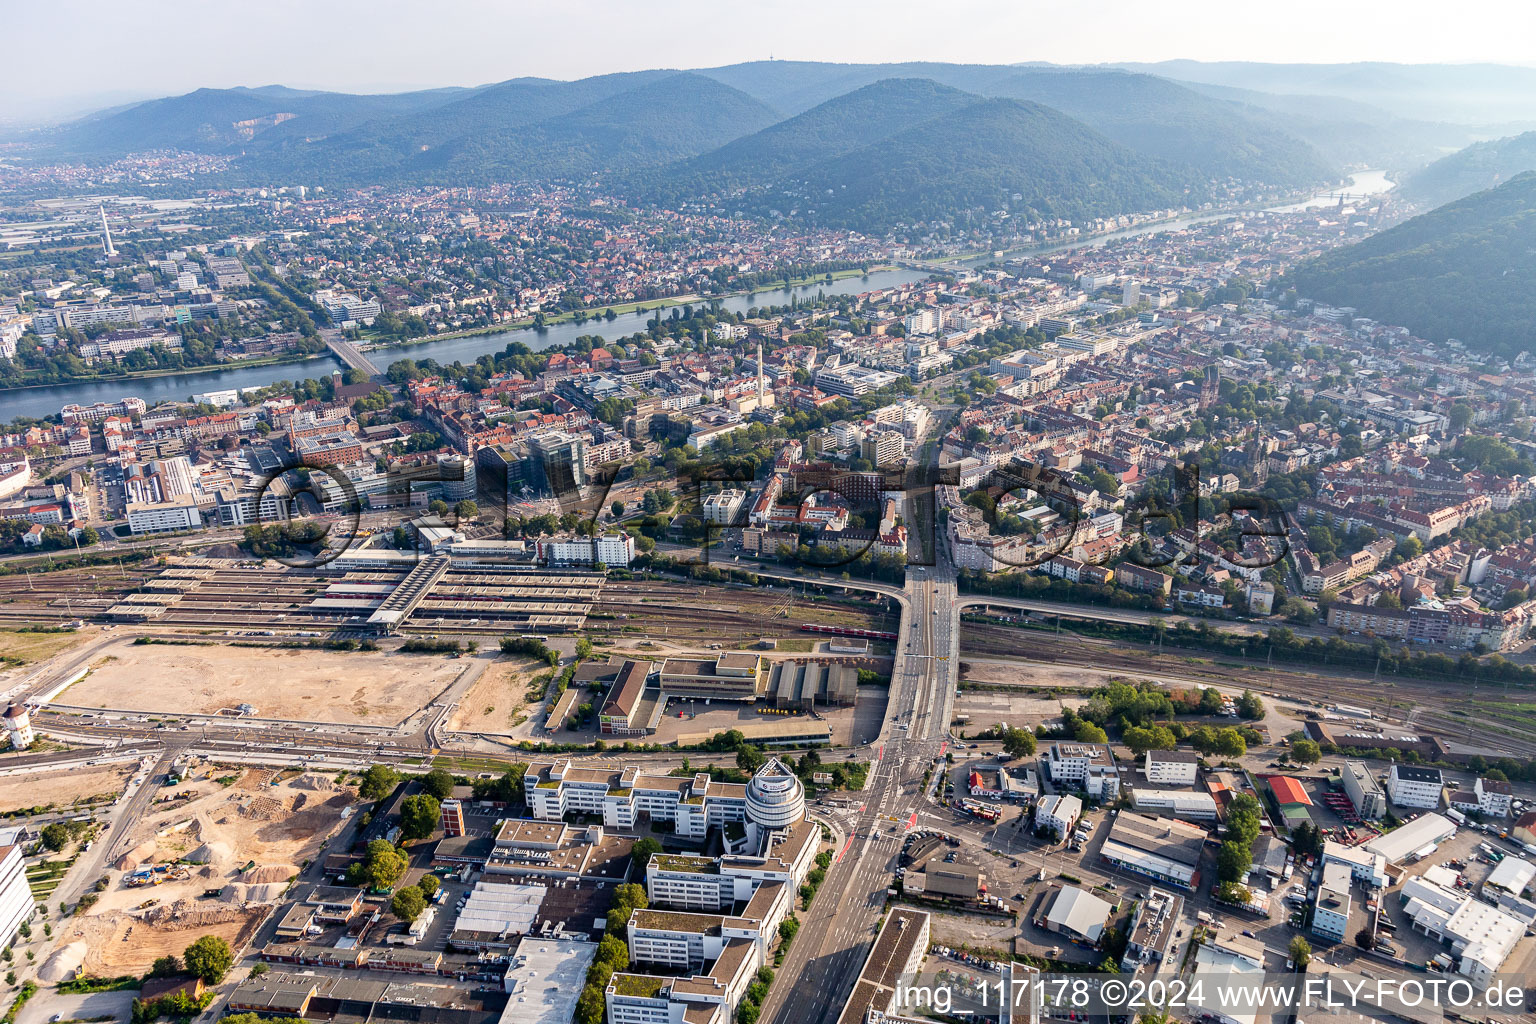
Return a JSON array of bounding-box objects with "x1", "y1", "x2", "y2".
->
[{"x1": 0, "y1": 170, "x2": 1393, "y2": 424}]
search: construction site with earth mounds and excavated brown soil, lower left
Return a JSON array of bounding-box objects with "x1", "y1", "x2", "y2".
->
[{"x1": 40, "y1": 761, "x2": 356, "y2": 981}]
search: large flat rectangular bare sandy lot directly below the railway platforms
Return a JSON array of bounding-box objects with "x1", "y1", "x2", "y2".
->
[{"x1": 57, "y1": 643, "x2": 467, "y2": 725}]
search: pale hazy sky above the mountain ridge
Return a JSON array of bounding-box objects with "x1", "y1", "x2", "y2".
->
[{"x1": 0, "y1": 0, "x2": 1536, "y2": 120}]
